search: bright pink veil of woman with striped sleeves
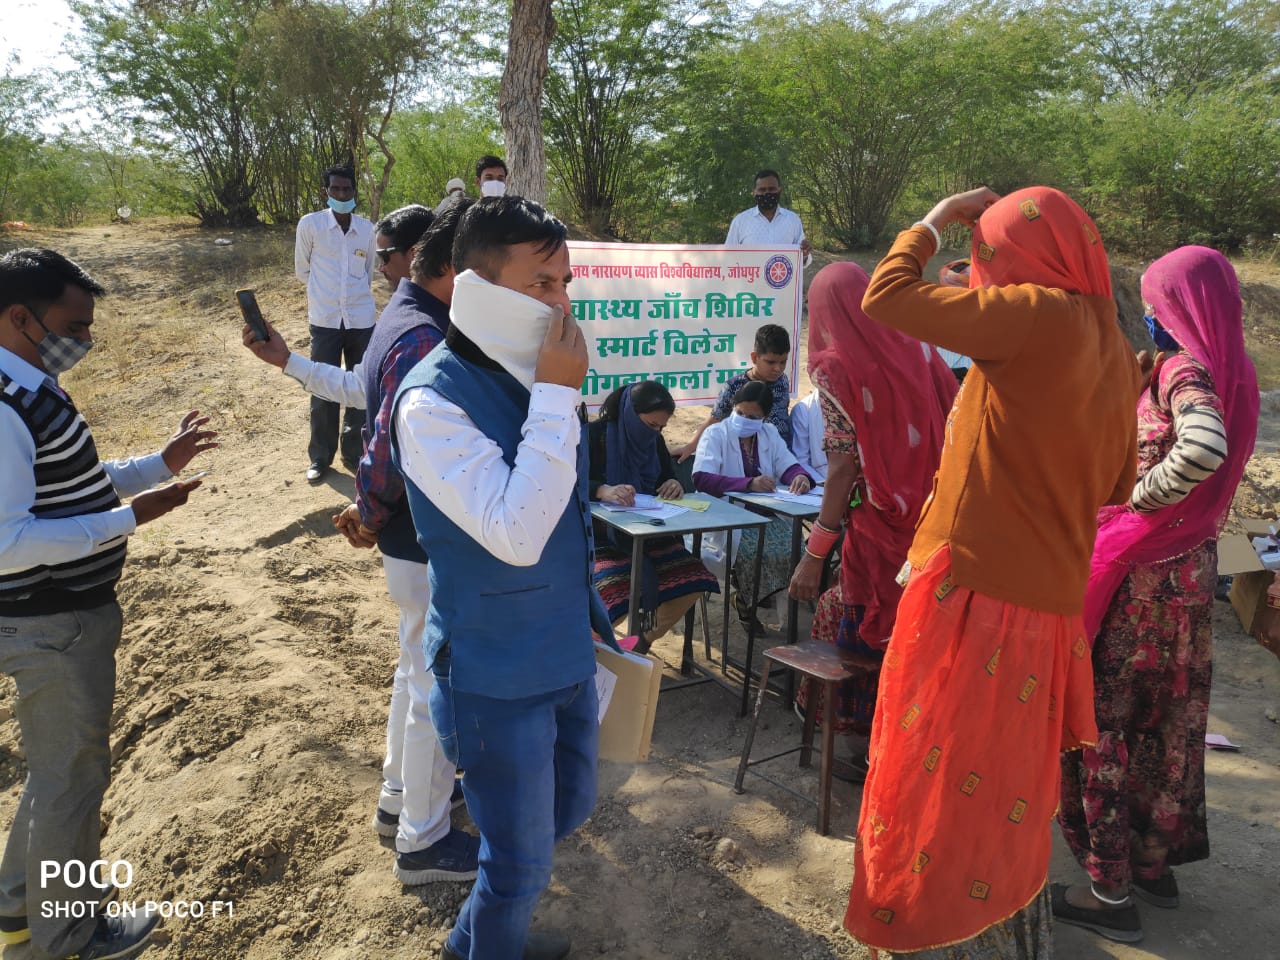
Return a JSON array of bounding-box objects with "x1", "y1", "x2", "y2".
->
[{"x1": 1084, "y1": 247, "x2": 1258, "y2": 637}]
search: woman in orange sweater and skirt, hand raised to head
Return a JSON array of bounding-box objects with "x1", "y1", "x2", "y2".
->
[{"x1": 845, "y1": 187, "x2": 1139, "y2": 960}]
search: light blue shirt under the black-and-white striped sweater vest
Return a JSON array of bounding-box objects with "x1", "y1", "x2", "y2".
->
[{"x1": 0, "y1": 347, "x2": 173, "y2": 572}]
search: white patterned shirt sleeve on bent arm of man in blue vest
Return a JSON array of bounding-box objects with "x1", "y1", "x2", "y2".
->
[{"x1": 396, "y1": 383, "x2": 582, "y2": 567}]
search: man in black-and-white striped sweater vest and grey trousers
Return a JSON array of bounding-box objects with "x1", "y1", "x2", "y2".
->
[{"x1": 0, "y1": 250, "x2": 216, "y2": 960}]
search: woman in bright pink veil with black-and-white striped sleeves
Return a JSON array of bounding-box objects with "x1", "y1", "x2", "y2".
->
[{"x1": 1053, "y1": 247, "x2": 1258, "y2": 942}]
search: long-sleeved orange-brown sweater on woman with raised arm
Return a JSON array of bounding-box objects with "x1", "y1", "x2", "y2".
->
[{"x1": 863, "y1": 227, "x2": 1140, "y2": 614}]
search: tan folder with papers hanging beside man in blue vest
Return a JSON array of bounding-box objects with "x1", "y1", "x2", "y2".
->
[{"x1": 595, "y1": 643, "x2": 662, "y2": 763}]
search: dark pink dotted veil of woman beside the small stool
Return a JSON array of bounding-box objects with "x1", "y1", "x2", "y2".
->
[{"x1": 809, "y1": 262, "x2": 957, "y2": 646}]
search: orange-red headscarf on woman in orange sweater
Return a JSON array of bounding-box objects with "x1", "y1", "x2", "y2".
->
[{"x1": 969, "y1": 187, "x2": 1111, "y2": 297}]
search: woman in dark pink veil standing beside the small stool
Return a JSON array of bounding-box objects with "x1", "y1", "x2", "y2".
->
[{"x1": 791, "y1": 262, "x2": 956, "y2": 780}]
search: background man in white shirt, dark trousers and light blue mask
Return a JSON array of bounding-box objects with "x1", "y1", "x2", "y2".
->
[{"x1": 293, "y1": 165, "x2": 378, "y2": 484}]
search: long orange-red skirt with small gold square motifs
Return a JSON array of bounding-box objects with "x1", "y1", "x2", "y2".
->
[{"x1": 845, "y1": 547, "x2": 1097, "y2": 952}]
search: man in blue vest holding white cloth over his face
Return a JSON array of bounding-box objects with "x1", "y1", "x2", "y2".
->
[{"x1": 392, "y1": 197, "x2": 611, "y2": 960}]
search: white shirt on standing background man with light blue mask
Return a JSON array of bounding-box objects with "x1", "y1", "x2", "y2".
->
[{"x1": 293, "y1": 210, "x2": 375, "y2": 329}]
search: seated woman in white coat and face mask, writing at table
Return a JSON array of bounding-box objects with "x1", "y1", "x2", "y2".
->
[{"x1": 694, "y1": 380, "x2": 813, "y2": 621}]
